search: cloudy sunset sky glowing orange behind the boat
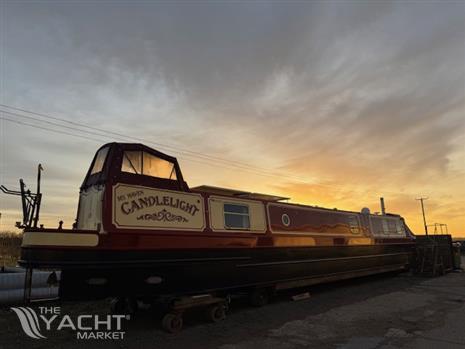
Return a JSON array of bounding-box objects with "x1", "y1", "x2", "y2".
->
[{"x1": 0, "y1": 0, "x2": 465, "y2": 236}]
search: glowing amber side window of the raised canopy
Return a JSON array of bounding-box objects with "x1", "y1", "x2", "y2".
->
[{"x1": 121, "y1": 151, "x2": 176, "y2": 180}]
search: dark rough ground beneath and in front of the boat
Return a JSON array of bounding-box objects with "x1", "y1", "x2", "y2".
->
[{"x1": 0, "y1": 260, "x2": 465, "y2": 349}]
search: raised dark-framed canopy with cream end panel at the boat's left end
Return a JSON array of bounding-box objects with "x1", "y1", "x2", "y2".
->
[{"x1": 74, "y1": 143, "x2": 189, "y2": 230}]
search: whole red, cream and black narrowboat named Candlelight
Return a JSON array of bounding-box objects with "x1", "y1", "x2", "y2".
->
[{"x1": 15, "y1": 143, "x2": 414, "y2": 299}]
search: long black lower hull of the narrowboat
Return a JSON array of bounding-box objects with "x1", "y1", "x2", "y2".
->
[{"x1": 20, "y1": 243, "x2": 413, "y2": 299}]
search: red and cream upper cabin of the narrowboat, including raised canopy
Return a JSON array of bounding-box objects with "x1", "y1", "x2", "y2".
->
[{"x1": 75, "y1": 143, "x2": 407, "y2": 245}]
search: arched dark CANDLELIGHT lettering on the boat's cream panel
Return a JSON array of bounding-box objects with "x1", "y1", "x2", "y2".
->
[{"x1": 121, "y1": 195, "x2": 200, "y2": 216}]
